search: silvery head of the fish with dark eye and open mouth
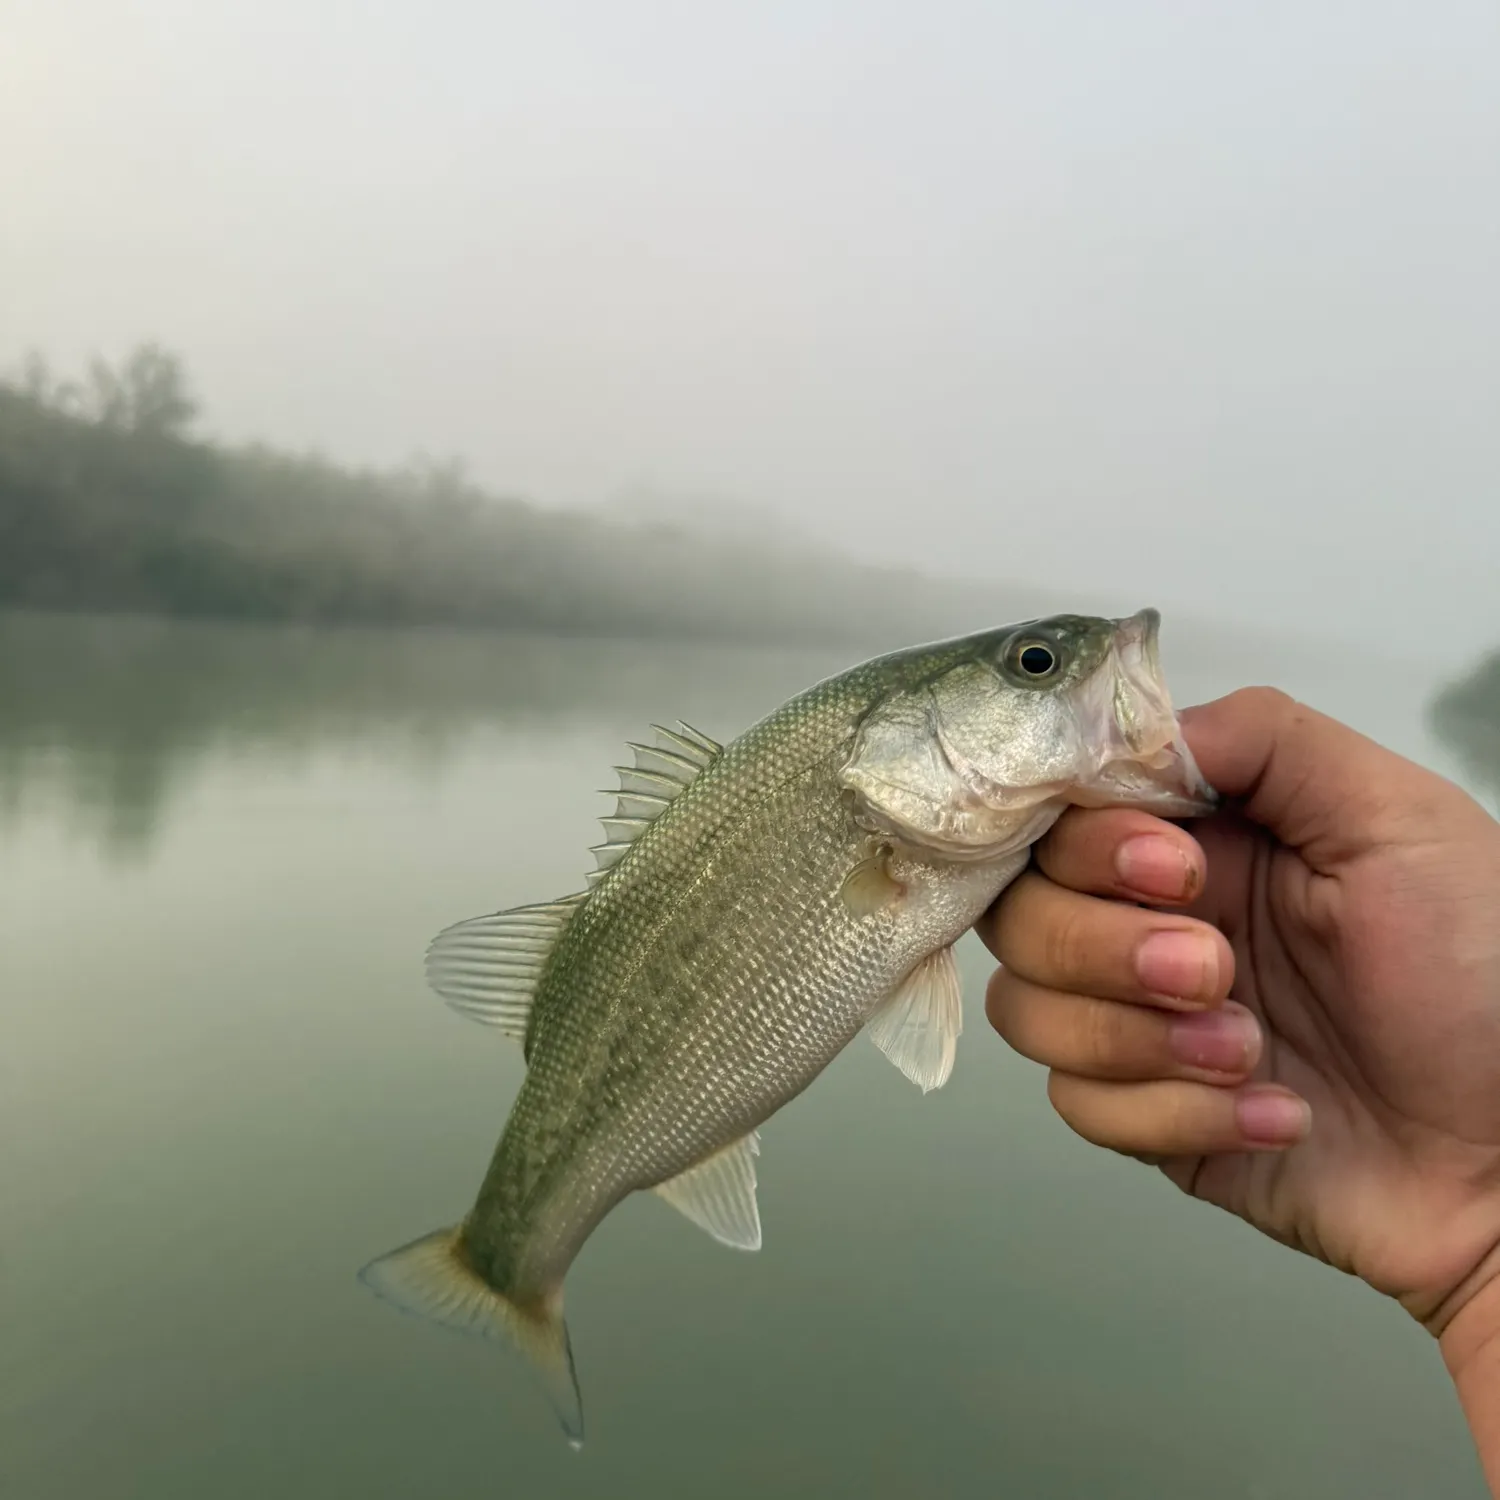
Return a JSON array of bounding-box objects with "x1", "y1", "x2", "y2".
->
[{"x1": 843, "y1": 609, "x2": 1217, "y2": 860}]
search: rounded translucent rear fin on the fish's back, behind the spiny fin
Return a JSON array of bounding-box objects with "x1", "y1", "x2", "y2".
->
[{"x1": 426, "y1": 891, "x2": 588, "y2": 1041}]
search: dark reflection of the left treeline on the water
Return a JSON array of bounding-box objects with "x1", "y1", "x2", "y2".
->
[{"x1": 0, "y1": 615, "x2": 858, "y2": 863}]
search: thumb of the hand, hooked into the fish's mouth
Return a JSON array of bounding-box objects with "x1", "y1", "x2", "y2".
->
[{"x1": 1181, "y1": 687, "x2": 1464, "y2": 869}]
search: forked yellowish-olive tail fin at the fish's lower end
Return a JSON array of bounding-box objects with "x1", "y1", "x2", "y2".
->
[{"x1": 360, "y1": 1229, "x2": 584, "y2": 1448}]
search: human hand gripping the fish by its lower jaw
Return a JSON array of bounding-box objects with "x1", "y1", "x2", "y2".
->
[{"x1": 980, "y1": 689, "x2": 1500, "y2": 1338}]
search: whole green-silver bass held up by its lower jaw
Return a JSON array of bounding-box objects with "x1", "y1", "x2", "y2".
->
[{"x1": 360, "y1": 609, "x2": 1217, "y2": 1448}]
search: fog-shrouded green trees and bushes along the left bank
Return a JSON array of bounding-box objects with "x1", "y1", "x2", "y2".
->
[{"x1": 0, "y1": 345, "x2": 1020, "y2": 642}]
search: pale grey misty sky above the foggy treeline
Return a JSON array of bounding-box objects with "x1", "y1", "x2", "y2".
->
[{"x1": 0, "y1": 0, "x2": 1500, "y2": 657}]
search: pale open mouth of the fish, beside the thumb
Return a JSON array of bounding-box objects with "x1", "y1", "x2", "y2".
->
[{"x1": 1073, "y1": 609, "x2": 1220, "y2": 818}]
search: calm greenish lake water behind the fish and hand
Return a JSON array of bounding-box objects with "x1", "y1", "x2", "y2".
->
[{"x1": 0, "y1": 620, "x2": 1484, "y2": 1500}]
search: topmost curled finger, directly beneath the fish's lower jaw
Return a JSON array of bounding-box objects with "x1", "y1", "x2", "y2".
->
[{"x1": 1035, "y1": 807, "x2": 1208, "y2": 906}]
